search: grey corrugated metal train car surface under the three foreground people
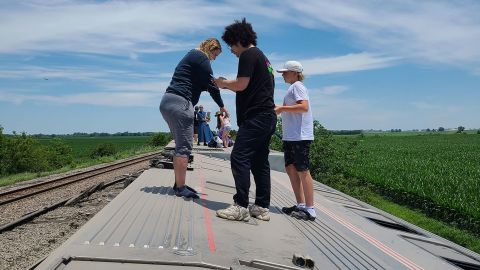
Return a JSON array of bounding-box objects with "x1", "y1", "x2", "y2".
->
[{"x1": 37, "y1": 154, "x2": 475, "y2": 269}]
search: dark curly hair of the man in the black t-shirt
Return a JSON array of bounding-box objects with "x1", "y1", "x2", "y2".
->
[{"x1": 222, "y1": 18, "x2": 257, "y2": 47}]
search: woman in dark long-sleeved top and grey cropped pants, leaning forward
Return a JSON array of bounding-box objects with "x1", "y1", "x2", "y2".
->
[{"x1": 160, "y1": 38, "x2": 227, "y2": 198}]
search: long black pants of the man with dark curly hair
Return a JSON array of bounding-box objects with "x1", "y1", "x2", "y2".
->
[{"x1": 230, "y1": 111, "x2": 277, "y2": 208}]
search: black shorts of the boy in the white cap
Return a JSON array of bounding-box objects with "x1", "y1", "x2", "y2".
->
[{"x1": 283, "y1": 141, "x2": 312, "y2": 172}]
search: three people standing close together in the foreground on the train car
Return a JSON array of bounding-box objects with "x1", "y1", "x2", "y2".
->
[{"x1": 160, "y1": 19, "x2": 316, "y2": 221}]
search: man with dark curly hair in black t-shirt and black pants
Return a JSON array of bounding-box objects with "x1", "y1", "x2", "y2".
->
[{"x1": 215, "y1": 18, "x2": 277, "y2": 221}]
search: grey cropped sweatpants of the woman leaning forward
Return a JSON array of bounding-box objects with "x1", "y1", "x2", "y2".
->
[{"x1": 160, "y1": 93, "x2": 194, "y2": 158}]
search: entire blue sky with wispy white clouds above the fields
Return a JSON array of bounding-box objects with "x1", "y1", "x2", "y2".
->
[{"x1": 0, "y1": 0, "x2": 480, "y2": 134}]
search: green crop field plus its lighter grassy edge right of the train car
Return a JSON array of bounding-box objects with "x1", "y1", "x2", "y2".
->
[{"x1": 317, "y1": 132, "x2": 480, "y2": 253}]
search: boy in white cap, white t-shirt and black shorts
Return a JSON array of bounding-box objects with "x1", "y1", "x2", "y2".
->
[{"x1": 275, "y1": 61, "x2": 317, "y2": 221}]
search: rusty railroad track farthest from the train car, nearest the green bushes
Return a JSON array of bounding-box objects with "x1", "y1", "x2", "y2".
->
[{"x1": 0, "y1": 153, "x2": 159, "y2": 206}]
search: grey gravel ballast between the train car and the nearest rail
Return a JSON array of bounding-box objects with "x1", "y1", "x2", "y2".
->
[{"x1": 0, "y1": 162, "x2": 148, "y2": 270}]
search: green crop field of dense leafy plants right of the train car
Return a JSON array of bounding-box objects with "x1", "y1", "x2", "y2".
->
[{"x1": 336, "y1": 133, "x2": 480, "y2": 221}]
